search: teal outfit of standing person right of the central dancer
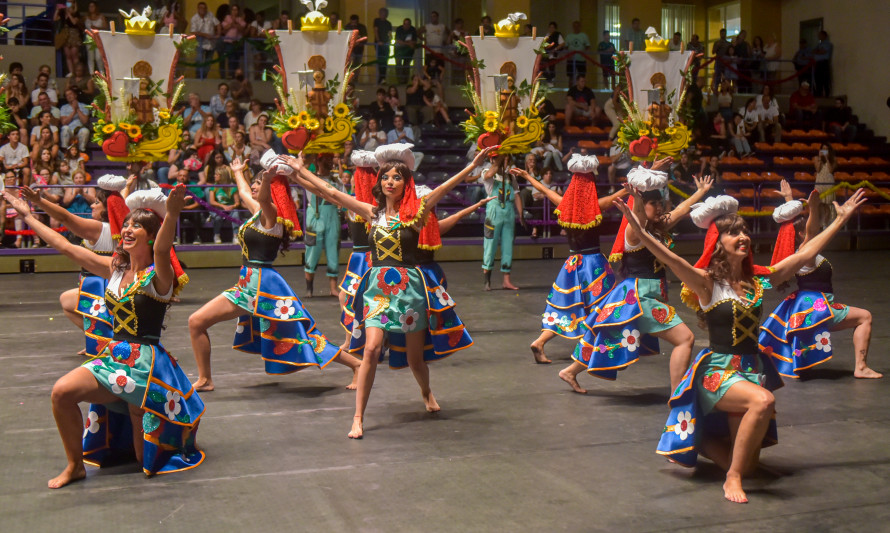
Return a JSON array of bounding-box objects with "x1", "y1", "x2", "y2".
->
[{"x1": 482, "y1": 175, "x2": 516, "y2": 273}]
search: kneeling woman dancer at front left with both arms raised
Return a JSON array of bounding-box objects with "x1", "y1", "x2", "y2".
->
[{"x1": 3, "y1": 187, "x2": 204, "y2": 489}]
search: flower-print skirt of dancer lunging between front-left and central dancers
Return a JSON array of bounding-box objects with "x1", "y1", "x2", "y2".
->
[{"x1": 223, "y1": 266, "x2": 340, "y2": 374}]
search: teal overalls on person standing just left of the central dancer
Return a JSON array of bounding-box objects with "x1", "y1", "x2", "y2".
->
[{"x1": 304, "y1": 178, "x2": 340, "y2": 278}]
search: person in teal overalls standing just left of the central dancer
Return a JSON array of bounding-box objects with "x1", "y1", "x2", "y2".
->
[{"x1": 303, "y1": 154, "x2": 340, "y2": 298}]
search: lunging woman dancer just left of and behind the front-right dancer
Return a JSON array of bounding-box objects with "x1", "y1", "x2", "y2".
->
[{"x1": 560, "y1": 167, "x2": 713, "y2": 392}]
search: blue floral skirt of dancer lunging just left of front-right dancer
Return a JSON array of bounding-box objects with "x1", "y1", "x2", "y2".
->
[{"x1": 572, "y1": 278, "x2": 683, "y2": 379}]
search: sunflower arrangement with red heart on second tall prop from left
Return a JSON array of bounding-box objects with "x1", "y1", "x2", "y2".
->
[{"x1": 269, "y1": 70, "x2": 361, "y2": 154}]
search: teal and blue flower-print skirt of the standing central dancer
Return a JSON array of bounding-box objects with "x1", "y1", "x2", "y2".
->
[{"x1": 349, "y1": 266, "x2": 473, "y2": 368}]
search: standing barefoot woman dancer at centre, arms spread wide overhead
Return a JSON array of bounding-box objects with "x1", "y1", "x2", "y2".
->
[{"x1": 282, "y1": 144, "x2": 492, "y2": 439}]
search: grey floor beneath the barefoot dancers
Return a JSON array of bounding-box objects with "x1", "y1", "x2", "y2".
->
[{"x1": 0, "y1": 252, "x2": 890, "y2": 532}]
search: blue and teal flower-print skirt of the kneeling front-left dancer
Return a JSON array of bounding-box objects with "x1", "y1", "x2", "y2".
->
[{"x1": 83, "y1": 340, "x2": 204, "y2": 475}]
